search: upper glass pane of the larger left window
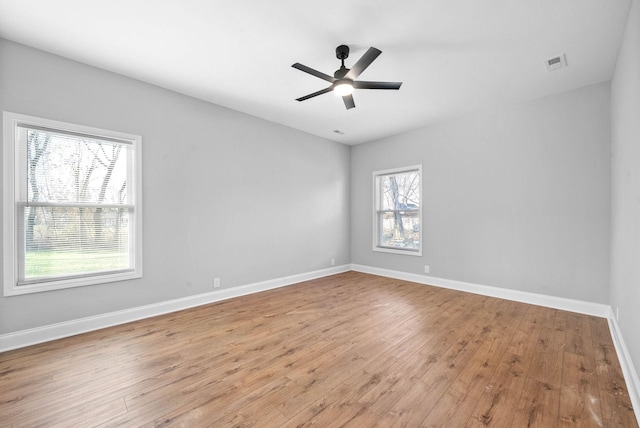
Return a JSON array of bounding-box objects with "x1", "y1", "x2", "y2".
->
[{"x1": 26, "y1": 129, "x2": 132, "y2": 204}]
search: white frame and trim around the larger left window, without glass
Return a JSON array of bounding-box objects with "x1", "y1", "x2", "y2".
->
[{"x1": 2, "y1": 111, "x2": 142, "y2": 296}]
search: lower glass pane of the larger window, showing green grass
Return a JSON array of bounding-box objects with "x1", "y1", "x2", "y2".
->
[{"x1": 21, "y1": 206, "x2": 133, "y2": 281}]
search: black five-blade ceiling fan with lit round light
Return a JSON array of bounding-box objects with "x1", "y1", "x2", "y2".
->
[{"x1": 292, "y1": 45, "x2": 402, "y2": 110}]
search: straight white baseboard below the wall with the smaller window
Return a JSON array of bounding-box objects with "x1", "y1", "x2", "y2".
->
[{"x1": 351, "y1": 264, "x2": 610, "y2": 318}]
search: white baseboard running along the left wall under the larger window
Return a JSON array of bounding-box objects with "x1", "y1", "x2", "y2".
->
[{"x1": 0, "y1": 265, "x2": 351, "y2": 352}]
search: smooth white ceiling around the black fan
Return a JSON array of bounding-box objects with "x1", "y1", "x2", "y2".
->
[{"x1": 0, "y1": 0, "x2": 630, "y2": 144}]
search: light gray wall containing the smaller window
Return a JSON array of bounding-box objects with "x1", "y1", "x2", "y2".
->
[{"x1": 351, "y1": 83, "x2": 610, "y2": 304}]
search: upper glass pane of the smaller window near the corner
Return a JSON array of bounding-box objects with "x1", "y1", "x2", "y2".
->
[{"x1": 380, "y1": 171, "x2": 420, "y2": 210}]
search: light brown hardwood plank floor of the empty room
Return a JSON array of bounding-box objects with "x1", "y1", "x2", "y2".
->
[{"x1": 0, "y1": 272, "x2": 637, "y2": 427}]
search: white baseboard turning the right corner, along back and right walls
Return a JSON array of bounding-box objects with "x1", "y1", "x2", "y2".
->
[{"x1": 351, "y1": 264, "x2": 640, "y2": 425}]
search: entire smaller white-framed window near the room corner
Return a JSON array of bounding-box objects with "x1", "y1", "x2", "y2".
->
[{"x1": 373, "y1": 165, "x2": 422, "y2": 256}]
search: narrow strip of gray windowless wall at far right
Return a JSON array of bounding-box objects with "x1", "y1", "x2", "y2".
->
[{"x1": 611, "y1": 0, "x2": 640, "y2": 374}]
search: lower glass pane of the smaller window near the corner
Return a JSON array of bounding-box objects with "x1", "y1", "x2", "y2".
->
[{"x1": 379, "y1": 211, "x2": 420, "y2": 250}]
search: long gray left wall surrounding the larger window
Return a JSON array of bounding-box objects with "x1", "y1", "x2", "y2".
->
[{"x1": 0, "y1": 40, "x2": 350, "y2": 334}]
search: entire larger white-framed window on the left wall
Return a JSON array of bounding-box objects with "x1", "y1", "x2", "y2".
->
[{"x1": 3, "y1": 112, "x2": 142, "y2": 296}]
